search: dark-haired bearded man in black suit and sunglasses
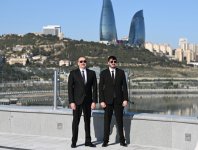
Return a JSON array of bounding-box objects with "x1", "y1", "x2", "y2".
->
[{"x1": 99, "y1": 56, "x2": 128, "y2": 147}]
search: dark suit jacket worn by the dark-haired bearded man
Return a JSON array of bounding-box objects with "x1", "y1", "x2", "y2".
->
[{"x1": 99, "y1": 68, "x2": 128, "y2": 104}]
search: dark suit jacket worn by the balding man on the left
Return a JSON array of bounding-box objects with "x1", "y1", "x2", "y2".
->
[{"x1": 68, "y1": 69, "x2": 97, "y2": 105}]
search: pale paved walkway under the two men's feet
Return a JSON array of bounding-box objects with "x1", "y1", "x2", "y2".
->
[{"x1": 0, "y1": 133, "x2": 175, "y2": 150}]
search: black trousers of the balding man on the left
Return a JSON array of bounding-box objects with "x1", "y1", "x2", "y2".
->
[{"x1": 72, "y1": 103, "x2": 91, "y2": 143}]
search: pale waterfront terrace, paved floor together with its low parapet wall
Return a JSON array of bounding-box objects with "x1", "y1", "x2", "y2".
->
[{"x1": 0, "y1": 105, "x2": 198, "y2": 150}]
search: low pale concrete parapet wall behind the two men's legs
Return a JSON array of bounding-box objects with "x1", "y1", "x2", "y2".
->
[{"x1": 0, "y1": 106, "x2": 198, "y2": 150}]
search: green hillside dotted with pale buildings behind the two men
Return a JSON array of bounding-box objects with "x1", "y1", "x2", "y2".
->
[{"x1": 0, "y1": 33, "x2": 197, "y2": 81}]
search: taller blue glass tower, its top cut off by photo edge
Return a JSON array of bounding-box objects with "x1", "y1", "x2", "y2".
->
[{"x1": 100, "y1": 0, "x2": 117, "y2": 42}]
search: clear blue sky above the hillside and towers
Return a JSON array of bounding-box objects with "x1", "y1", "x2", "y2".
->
[{"x1": 0, "y1": 0, "x2": 198, "y2": 48}]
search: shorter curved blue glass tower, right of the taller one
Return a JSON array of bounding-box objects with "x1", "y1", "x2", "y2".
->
[{"x1": 128, "y1": 10, "x2": 145, "y2": 47}]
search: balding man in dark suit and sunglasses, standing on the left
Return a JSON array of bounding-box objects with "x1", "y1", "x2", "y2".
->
[{"x1": 68, "y1": 57, "x2": 97, "y2": 148}]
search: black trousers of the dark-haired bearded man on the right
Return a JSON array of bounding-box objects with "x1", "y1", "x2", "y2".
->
[{"x1": 103, "y1": 104, "x2": 125, "y2": 143}]
